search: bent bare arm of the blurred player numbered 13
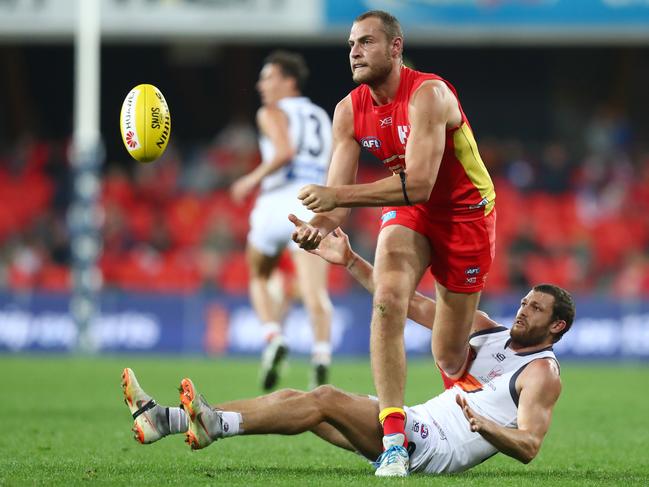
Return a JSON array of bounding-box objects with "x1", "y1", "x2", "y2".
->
[{"x1": 231, "y1": 107, "x2": 295, "y2": 202}]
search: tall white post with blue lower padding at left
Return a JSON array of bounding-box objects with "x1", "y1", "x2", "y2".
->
[{"x1": 68, "y1": 0, "x2": 104, "y2": 353}]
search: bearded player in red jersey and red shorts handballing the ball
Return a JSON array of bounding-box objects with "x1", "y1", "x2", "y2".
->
[{"x1": 289, "y1": 11, "x2": 496, "y2": 476}]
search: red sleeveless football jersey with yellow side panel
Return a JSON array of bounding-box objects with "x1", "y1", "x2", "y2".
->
[{"x1": 351, "y1": 66, "x2": 496, "y2": 221}]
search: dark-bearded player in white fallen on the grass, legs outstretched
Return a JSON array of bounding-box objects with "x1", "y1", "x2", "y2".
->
[{"x1": 122, "y1": 230, "x2": 575, "y2": 473}]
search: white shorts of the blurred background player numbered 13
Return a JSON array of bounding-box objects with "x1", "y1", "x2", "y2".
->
[{"x1": 248, "y1": 182, "x2": 313, "y2": 257}]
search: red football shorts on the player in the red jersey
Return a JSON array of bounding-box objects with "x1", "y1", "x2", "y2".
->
[{"x1": 381, "y1": 206, "x2": 496, "y2": 293}]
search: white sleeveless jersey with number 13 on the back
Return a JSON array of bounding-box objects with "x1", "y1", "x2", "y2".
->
[{"x1": 259, "y1": 96, "x2": 332, "y2": 191}]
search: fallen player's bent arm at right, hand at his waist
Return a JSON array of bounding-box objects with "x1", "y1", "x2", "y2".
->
[{"x1": 456, "y1": 359, "x2": 561, "y2": 463}]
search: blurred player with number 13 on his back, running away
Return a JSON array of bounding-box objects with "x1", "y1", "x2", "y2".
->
[{"x1": 231, "y1": 51, "x2": 332, "y2": 390}]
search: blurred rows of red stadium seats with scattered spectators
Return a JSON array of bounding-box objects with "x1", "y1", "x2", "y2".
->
[{"x1": 0, "y1": 137, "x2": 649, "y2": 295}]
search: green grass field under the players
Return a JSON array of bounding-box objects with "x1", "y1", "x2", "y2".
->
[{"x1": 0, "y1": 356, "x2": 649, "y2": 487}]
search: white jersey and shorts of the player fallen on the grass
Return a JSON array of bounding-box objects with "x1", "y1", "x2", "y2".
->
[{"x1": 407, "y1": 326, "x2": 556, "y2": 473}]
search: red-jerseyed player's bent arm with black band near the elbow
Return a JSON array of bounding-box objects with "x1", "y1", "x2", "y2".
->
[{"x1": 300, "y1": 80, "x2": 459, "y2": 213}]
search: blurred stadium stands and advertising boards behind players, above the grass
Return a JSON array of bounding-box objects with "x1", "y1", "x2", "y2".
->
[{"x1": 0, "y1": 0, "x2": 649, "y2": 360}]
